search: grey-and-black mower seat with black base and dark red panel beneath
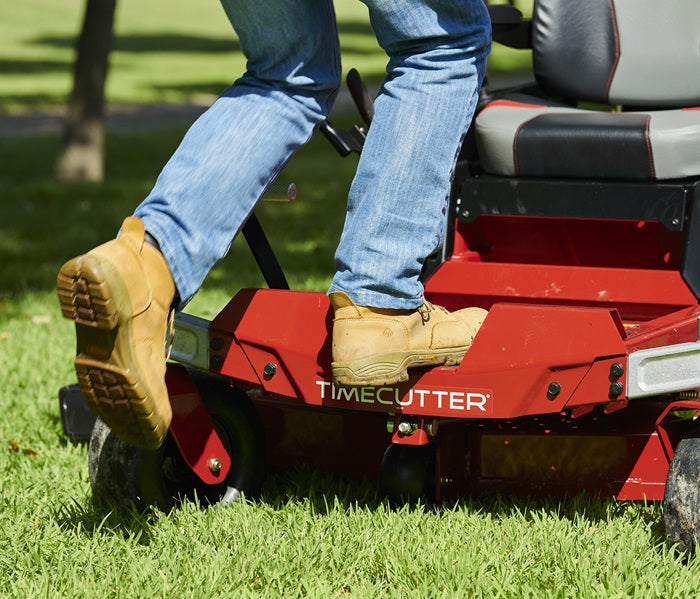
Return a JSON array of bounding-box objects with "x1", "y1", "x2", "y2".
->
[{"x1": 454, "y1": 0, "x2": 700, "y2": 298}]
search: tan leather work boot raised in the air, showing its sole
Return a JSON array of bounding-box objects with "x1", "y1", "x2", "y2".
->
[{"x1": 57, "y1": 217, "x2": 175, "y2": 449}]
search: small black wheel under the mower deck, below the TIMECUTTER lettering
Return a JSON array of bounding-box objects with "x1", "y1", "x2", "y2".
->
[{"x1": 379, "y1": 444, "x2": 435, "y2": 504}]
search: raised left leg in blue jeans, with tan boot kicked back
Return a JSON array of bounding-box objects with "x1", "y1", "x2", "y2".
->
[{"x1": 57, "y1": 0, "x2": 340, "y2": 448}]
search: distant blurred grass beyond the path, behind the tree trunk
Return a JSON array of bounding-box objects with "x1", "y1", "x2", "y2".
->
[{"x1": 0, "y1": 0, "x2": 531, "y2": 114}]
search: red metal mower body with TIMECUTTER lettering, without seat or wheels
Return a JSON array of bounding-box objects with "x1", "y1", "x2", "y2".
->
[{"x1": 167, "y1": 209, "x2": 700, "y2": 500}]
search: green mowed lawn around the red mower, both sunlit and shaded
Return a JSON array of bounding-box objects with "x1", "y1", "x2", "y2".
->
[{"x1": 0, "y1": 0, "x2": 700, "y2": 598}]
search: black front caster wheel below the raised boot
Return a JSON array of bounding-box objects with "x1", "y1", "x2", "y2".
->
[{"x1": 88, "y1": 371, "x2": 265, "y2": 511}]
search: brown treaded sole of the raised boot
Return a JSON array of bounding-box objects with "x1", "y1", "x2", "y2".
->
[{"x1": 57, "y1": 255, "x2": 165, "y2": 449}]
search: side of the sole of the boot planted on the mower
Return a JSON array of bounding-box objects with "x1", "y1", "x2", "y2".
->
[{"x1": 331, "y1": 346, "x2": 469, "y2": 387}]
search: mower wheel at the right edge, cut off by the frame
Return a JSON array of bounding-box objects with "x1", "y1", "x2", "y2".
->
[{"x1": 664, "y1": 422, "x2": 700, "y2": 553}]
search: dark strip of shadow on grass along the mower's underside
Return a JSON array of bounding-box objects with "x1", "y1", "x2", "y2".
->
[{"x1": 54, "y1": 468, "x2": 667, "y2": 555}]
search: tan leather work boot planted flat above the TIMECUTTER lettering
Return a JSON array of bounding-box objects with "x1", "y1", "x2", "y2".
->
[{"x1": 329, "y1": 291, "x2": 487, "y2": 387}]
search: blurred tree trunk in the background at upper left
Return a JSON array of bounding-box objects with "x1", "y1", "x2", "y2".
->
[{"x1": 56, "y1": 0, "x2": 116, "y2": 181}]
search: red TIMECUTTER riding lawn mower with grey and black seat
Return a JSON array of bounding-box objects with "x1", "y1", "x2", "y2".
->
[{"x1": 60, "y1": 0, "x2": 700, "y2": 550}]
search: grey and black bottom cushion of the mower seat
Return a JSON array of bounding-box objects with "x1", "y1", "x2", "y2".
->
[{"x1": 476, "y1": 98, "x2": 700, "y2": 181}]
